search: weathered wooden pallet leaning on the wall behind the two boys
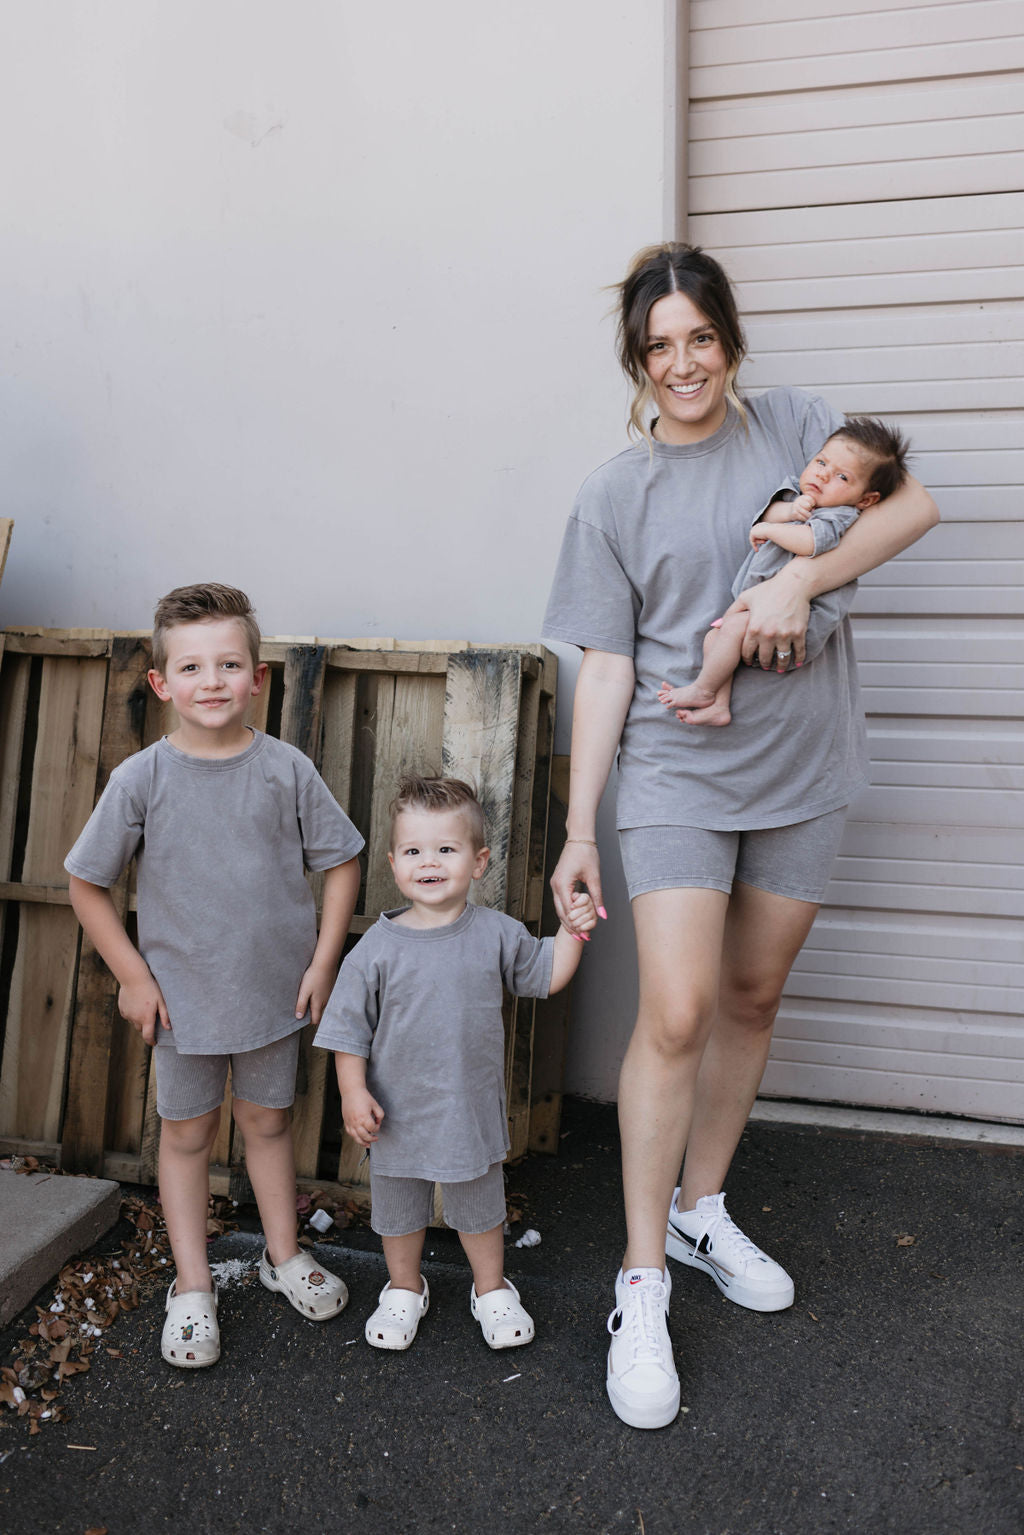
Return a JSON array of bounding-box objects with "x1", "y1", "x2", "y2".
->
[{"x1": 0, "y1": 629, "x2": 567, "y2": 1197}]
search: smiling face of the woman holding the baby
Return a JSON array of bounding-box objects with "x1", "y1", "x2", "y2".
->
[{"x1": 643, "y1": 293, "x2": 729, "y2": 444}]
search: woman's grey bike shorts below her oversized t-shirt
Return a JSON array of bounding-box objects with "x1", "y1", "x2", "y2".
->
[{"x1": 619, "y1": 806, "x2": 847, "y2": 904}]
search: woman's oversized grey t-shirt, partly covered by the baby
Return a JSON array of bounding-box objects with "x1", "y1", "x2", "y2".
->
[{"x1": 543, "y1": 388, "x2": 866, "y2": 830}]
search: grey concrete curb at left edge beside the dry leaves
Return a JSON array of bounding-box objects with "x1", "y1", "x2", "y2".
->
[{"x1": 0, "y1": 1168, "x2": 121, "y2": 1326}]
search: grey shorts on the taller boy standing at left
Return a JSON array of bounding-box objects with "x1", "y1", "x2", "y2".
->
[{"x1": 154, "y1": 1030, "x2": 299, "y2": 1119}]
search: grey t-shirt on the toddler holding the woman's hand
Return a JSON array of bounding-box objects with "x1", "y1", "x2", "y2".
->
[{"x1": 313, "y1": 906, "x2": 554, "y2": 1183}]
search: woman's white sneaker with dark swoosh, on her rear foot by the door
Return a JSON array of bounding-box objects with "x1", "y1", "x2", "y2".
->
[{"x1": 665, "y1": 1190, "x2": 794, "y2": 1311}]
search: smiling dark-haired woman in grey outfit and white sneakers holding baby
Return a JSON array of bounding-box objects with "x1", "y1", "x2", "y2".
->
[{"x1": 543, "y1": 244, "x2": 938, "y2": 1428}]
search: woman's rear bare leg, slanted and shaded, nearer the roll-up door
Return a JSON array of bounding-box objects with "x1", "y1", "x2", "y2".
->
[{"x1": 669, "y1": 881, "x2": 818, "y2": 1210}]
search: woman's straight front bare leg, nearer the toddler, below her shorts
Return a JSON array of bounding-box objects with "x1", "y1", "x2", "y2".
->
[{"x1": 619, "y1": 889, "x2": 738, "y2": 1269}]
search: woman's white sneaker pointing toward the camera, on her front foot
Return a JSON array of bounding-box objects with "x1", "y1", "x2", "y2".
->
[{"x1": 608, "y1": 1268, "x2": 679, "y2": 1429}]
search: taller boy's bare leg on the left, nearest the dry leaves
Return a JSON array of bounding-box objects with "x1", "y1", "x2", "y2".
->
[{"x1": 160, "y1": 1108, "x2": 221, "y2": 1296}]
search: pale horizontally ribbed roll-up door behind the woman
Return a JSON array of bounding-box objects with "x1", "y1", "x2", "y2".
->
[{"x1": 688, "y1": 0, "x2": 1024, "y2": 1119}]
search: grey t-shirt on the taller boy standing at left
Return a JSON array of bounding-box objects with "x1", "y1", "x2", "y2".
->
[{"x1": 64, "y1": 731, "x2": 362, "y2": 1055}]
